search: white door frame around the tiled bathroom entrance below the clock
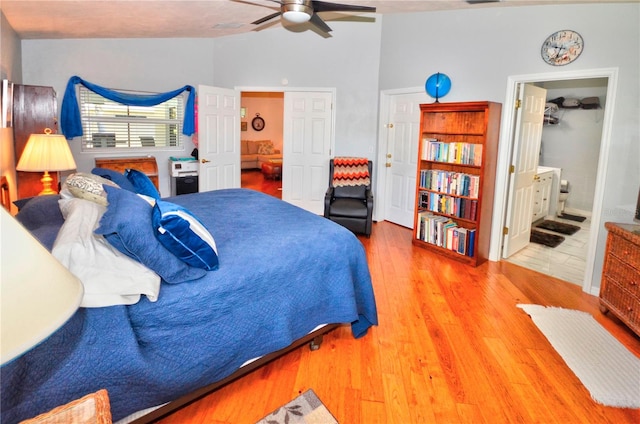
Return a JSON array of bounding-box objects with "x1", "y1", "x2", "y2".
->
[{"x1": 489, "y1": 68, "x2": 618, "y2": 295}]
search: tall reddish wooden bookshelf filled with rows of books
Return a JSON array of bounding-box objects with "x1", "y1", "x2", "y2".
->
[{"x1": 413, "y1": 102, "x2": 502, "y2": 266}]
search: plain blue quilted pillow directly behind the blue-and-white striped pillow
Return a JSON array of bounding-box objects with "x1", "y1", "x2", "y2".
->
[{"x1": 95, "y1": 185, "x2": 207, "y2": 283}]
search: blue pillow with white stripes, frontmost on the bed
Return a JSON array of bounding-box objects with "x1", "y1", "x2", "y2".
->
[{"x1": 153, "y1": 200, "x2": 218, "y2": 271}]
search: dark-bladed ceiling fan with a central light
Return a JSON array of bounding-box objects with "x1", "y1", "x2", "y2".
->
[{"x1": 251, "y1": 0, "x2": 376, "y2": 32}]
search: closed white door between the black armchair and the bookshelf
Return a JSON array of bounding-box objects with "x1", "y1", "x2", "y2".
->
[{"x1": 384, "y1": 93, "x2": 426, "y2": 228}]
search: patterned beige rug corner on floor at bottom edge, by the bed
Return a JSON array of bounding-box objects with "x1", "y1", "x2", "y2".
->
[{"x1": 256, "y1": 389, "x2": 338, "y2": 424}]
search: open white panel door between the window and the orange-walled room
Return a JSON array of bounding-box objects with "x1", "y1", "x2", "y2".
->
[{"x1": 198, "y1": 85, "x2": 240, "y2": 191}]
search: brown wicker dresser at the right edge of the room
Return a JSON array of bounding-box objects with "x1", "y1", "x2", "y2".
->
[{"x1": 600, "y1": 222, "x2": 640, "y2": 336}]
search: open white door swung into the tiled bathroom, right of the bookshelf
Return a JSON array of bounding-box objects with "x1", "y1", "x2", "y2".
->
[{"x1": 502, "y1": 84, "x2": 547, "y2": 258}]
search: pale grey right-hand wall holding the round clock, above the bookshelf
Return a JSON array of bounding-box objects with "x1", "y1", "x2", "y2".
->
[{"x1": 380, "y1": 3, "x2": 640, "y2": 294}]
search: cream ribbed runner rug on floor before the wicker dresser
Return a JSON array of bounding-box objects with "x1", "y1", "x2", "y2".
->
[{"x1": 518, "y1": 304, "x2": 640, "y2": 408}]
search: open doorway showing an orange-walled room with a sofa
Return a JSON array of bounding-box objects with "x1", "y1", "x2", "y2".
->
[{"x1": 240, "y1": 91, "x2": 284, "y2": 199}]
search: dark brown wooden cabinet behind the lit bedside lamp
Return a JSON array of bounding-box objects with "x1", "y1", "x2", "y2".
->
[{"x1": 13, "y1": 84, "x2": 58, "y2": 199}]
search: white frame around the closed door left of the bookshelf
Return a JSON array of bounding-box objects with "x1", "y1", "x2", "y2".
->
[{"x1": 373, "y1": 86, "x2": 427, "y2": 221}]
